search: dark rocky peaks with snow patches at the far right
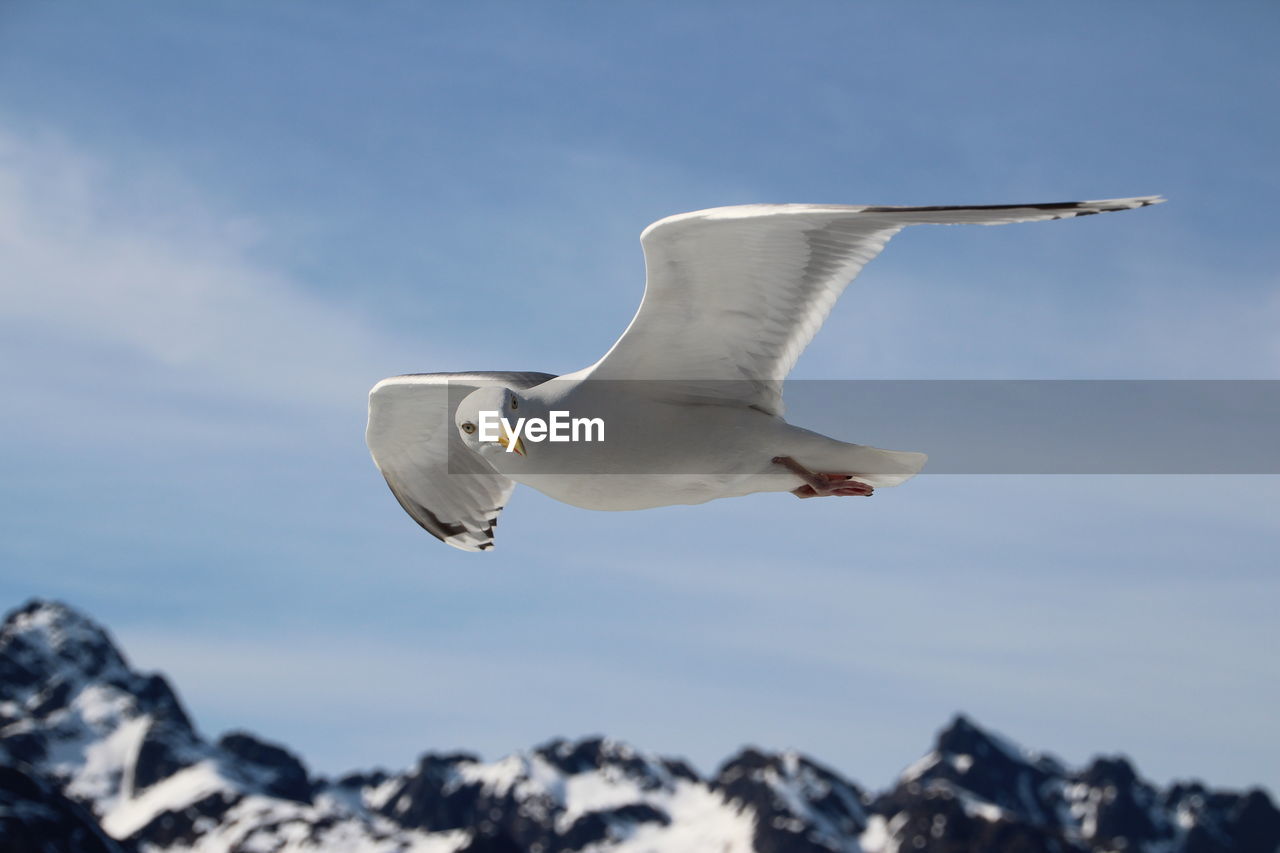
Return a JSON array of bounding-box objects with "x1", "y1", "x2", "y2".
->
[{"x1": 872, "y1": 717, "x2": 1280, "y2": 853}]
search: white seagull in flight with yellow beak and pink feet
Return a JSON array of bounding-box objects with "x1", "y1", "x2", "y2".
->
[{"x1": 365, "y1": 196, "x2": 1164, "y2": 551}]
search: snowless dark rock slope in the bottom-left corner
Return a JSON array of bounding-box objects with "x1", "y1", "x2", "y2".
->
[{"x1": 0, "y1": 765, "x2": 132, "y2": 853}]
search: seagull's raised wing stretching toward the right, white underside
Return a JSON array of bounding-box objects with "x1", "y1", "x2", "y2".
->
[{"x1": 590, "y1": 196, "x2": 1164, "y2": 415}]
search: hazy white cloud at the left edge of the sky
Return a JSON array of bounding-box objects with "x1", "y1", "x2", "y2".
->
[{"x1": 0, "y1": 121, "x2": 426, "y2": 406}]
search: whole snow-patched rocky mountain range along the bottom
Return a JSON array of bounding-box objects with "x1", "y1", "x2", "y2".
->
[{"x1": 0, "y1": 601, "x2": 1280, "y2": 853}]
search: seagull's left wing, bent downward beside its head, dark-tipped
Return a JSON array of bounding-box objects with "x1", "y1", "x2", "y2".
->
[{"x1": 365, "y1": 373, "x2": 554, "y2": 551}]
